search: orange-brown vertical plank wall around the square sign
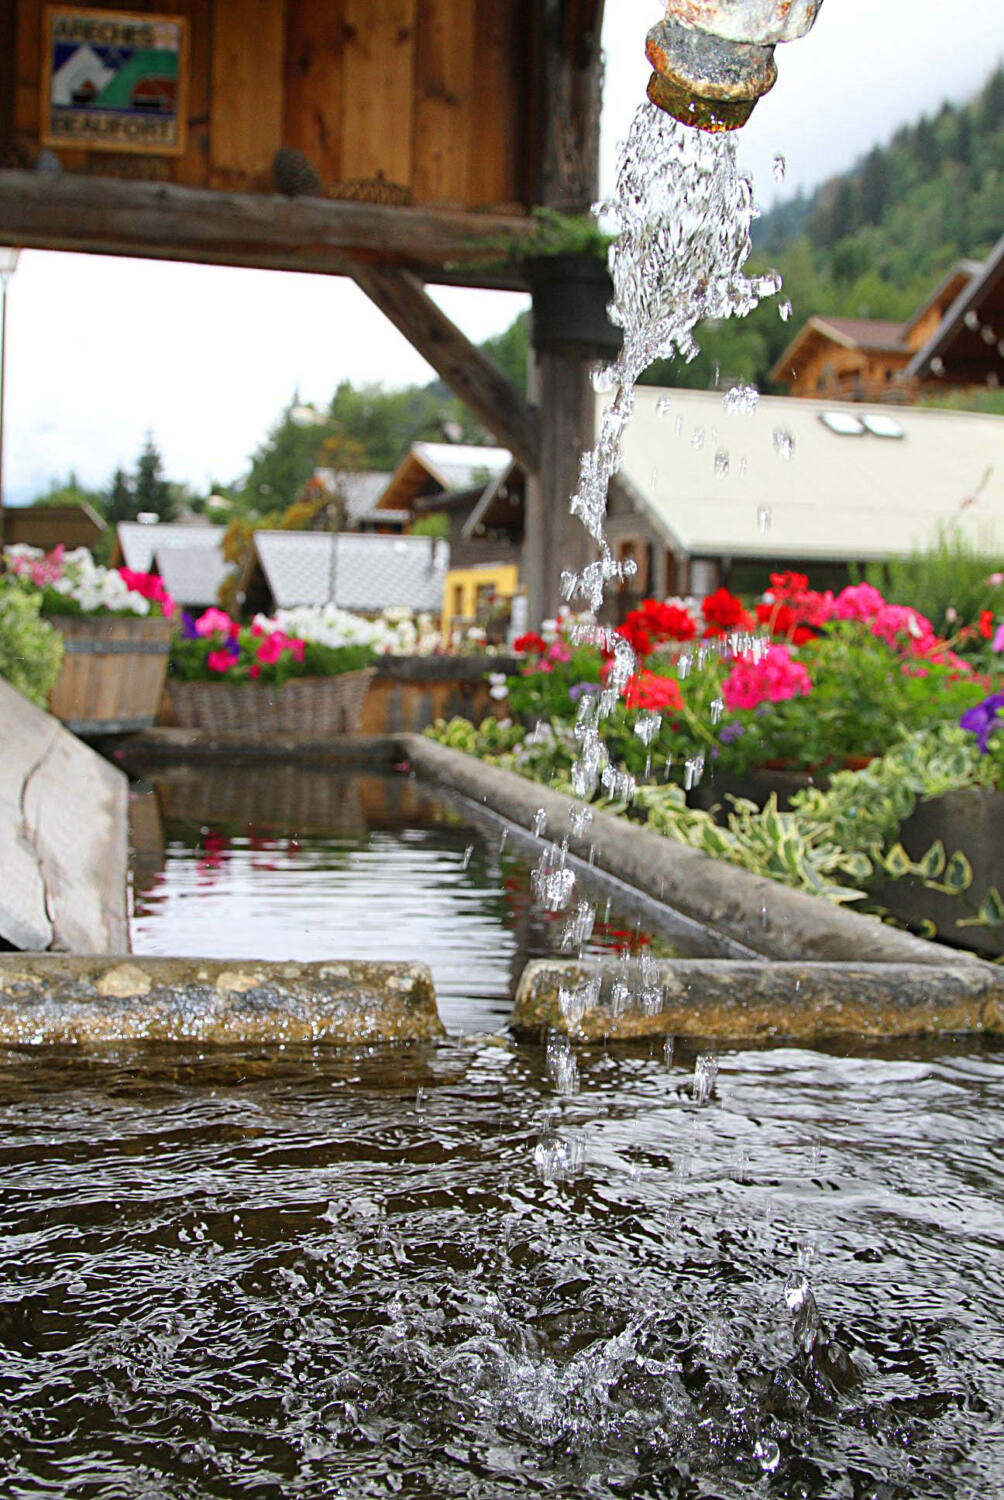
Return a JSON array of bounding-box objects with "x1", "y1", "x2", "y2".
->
[{"x1": 9, "y1": 0, "x2": 536, "y2": 210}]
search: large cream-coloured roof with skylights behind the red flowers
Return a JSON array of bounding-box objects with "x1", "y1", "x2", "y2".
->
[{"x1": 612, "y1": 386, "x2": 1004, "y2": 560}]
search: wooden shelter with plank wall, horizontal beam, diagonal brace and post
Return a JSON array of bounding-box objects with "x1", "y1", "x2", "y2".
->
[{"x1": 0, "y1": 0, "x2": 603, "y2": 621}]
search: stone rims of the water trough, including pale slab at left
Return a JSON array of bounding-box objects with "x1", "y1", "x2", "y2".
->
[{"x1": 0, "y1": 684, "x2": 1004, "y2": 1046}]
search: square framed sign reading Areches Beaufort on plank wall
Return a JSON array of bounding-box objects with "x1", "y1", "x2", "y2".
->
[{"x1": 42, "y1": 6, "x2": 188, "y2": 156}]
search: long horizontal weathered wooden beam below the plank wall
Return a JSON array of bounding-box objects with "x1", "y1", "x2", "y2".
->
[{"x1": 0, "y1": 171, "x2": 533, "y2": 290}]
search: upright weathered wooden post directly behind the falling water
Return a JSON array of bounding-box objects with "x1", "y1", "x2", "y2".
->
[{"x1": 524, "y1": 0, "x2": 603, "y2": 630}]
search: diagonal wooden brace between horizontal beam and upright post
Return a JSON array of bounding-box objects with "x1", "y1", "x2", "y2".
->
[{"x1": 353, "y1": 266, "x2": 540, "y2": 473}]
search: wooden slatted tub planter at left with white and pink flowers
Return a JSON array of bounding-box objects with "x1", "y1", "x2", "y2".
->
[{"x1": 47, "y1": 615, "x2": 171, "y2": 735}]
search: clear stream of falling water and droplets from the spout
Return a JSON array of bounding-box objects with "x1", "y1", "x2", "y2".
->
[{"x1": 534, "y1": 104, "x2": 780, "y2": 1146}]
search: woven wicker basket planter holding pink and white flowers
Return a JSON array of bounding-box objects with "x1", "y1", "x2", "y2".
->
[{"x1": 168, "y1": 668, "x2": 374, "y2": 741}]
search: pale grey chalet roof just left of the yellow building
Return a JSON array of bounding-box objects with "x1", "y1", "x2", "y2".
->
[{"x1": 254, "y1": 531, "x2": 450, "y2": 614}]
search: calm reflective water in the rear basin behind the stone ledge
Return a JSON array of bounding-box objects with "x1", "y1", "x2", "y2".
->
[{"x1": 131, "y1": 765, "x2": 744, "y2": 1031}]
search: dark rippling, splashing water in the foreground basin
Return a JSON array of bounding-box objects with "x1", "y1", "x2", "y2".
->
[{"x1": 0, "y1": 1041, "x2": 1004, "y2": 1500}]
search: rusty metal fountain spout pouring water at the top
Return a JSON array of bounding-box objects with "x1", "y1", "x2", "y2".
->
[{"x1": 645, "y1": 0, "x2": 822, "y2": 131}]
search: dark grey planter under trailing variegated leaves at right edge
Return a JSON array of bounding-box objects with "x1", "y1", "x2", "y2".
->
[{"x1": 869, "y1": 788, "x2": 1004, "y2": 959}]
